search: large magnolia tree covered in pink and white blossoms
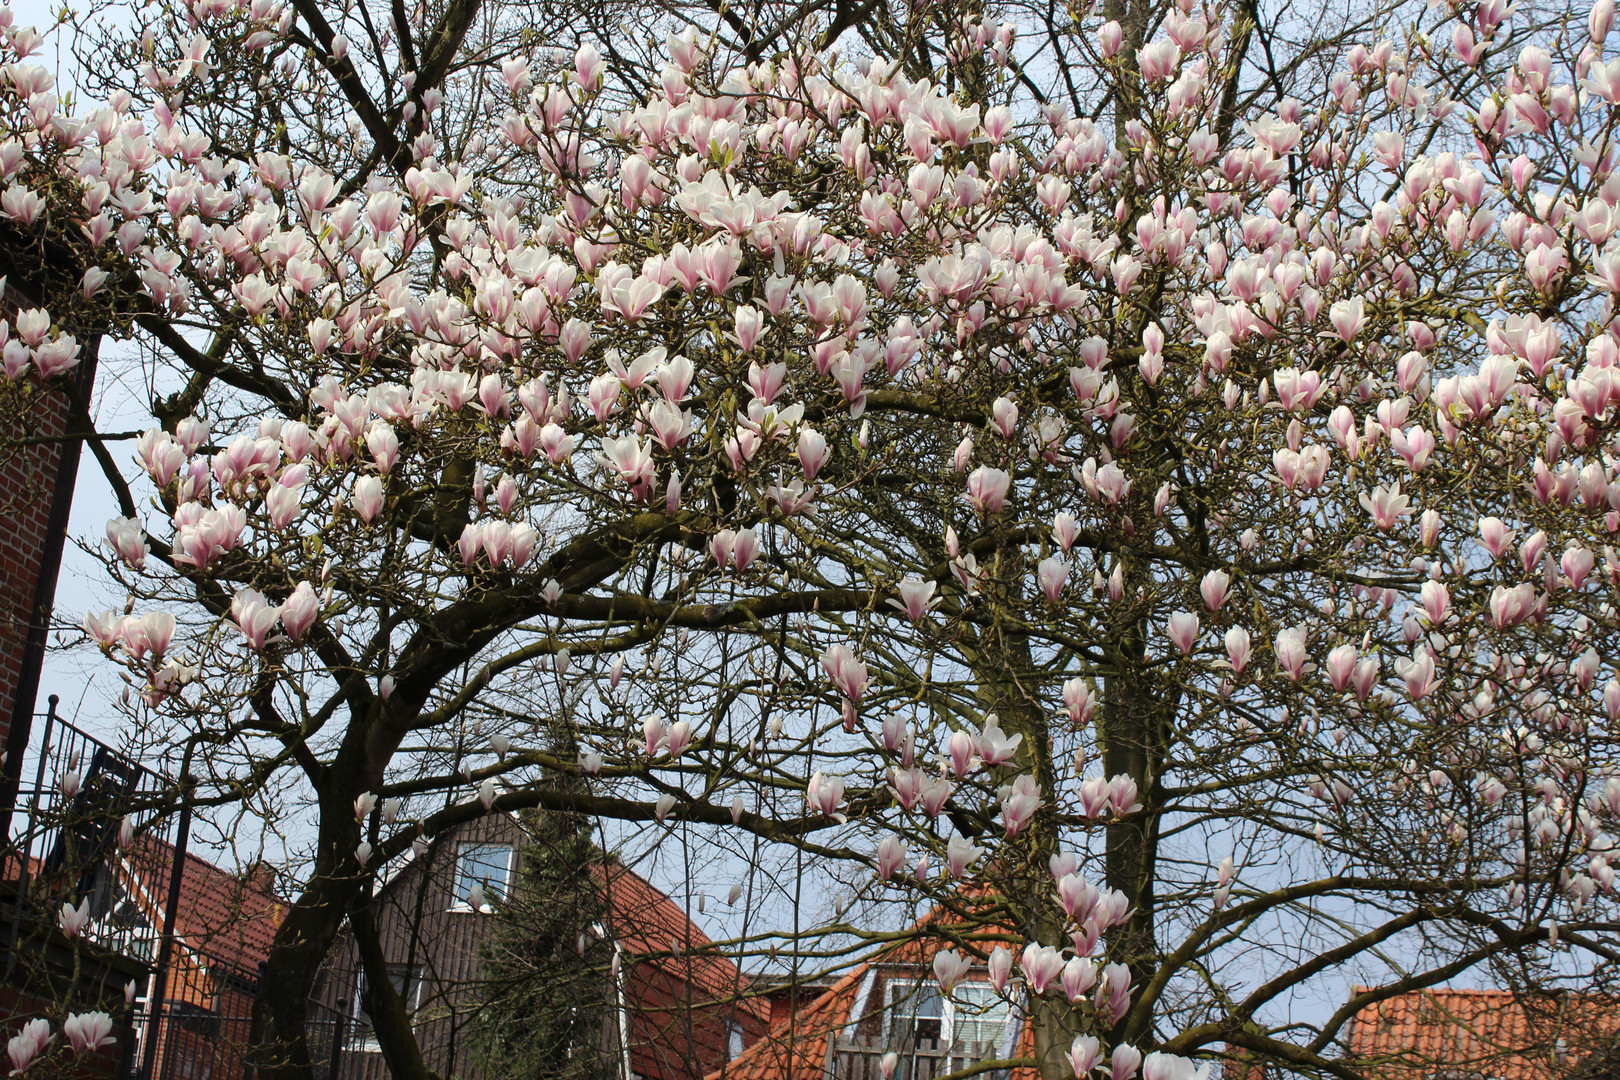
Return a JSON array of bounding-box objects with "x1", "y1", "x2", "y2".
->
[{"x1": 0, "y1": 0, "x2": 1620, "y2": 1080}]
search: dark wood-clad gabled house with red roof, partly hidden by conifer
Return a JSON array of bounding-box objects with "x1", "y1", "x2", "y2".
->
[{"x1": 316, "y1": 814, "x2": 770, "y2": 1080}]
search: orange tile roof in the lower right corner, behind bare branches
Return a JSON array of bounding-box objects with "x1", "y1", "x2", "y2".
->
[{"x1": 1349, "y1": 988, "x2": 1620, "y2": 1080}]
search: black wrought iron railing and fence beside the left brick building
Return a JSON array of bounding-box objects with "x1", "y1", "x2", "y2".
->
[{"x1": 0, "y1": 696, "x2": 350, "y2": 1080}]
